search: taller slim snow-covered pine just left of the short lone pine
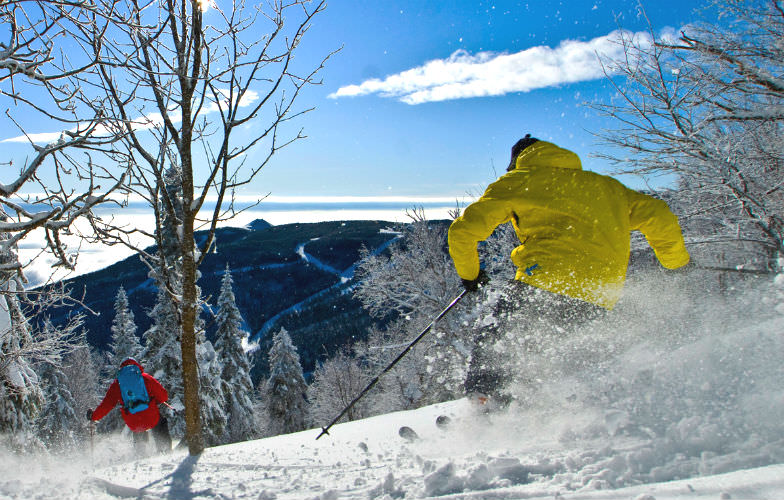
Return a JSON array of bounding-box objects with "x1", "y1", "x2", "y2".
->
[{"x1": 215, "y1": 264, "x2": 256, "y2": 443}]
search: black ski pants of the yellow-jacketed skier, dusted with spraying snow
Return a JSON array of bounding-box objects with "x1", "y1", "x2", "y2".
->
[{"x1": 463, "y1": 280, "x2": 605, "y2": 402}]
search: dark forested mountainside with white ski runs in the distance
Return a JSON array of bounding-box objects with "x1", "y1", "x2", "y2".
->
[{"x1": 47, "y1": 220, "x2": 428, "y2": 380}]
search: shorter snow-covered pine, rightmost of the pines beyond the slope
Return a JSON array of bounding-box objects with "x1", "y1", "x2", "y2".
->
[{"x1": 263, "y1": 328, "x2": 308, "y2": 434}]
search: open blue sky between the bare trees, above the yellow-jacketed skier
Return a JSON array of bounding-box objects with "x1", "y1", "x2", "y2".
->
[{"x1": 254, "y1": 0, "x2": 700, "y2": 197}]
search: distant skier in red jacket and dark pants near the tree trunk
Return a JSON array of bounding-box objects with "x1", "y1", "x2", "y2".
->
[{"x1": 87, "y1": 358, "x2": 171, "y2": 452}]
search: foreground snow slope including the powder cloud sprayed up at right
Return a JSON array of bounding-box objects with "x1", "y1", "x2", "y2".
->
[{"x1": 6, "y1": 276, "x2": 784, "y2": 500}]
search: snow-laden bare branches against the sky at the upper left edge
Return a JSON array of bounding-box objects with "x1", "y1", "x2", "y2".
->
[{"x1": 0, "y1": 0, "x2": 124, "y2": 276}]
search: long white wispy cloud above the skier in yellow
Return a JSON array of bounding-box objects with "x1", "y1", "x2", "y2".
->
[{"x1": 329, "y1": 30, "x2": 650, "y2": 104}]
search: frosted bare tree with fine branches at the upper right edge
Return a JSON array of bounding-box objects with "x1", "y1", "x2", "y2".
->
[{"x1": 596, "y1": 0, "x2": 784, "y2": 269}]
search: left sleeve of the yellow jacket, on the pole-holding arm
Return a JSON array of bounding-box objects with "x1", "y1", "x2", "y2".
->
[{"x1": 447, "y1": 179, "x2": 512, "y2": 280}]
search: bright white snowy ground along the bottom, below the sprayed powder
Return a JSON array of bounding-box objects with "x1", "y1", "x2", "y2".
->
[{"x1": 0, "y1": 394, "x2": 784, "y2": 500}]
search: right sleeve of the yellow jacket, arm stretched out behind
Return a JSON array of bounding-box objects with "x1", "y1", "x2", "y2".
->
[{"x1": 627, "y1": 190, "x2": 689, "y2": 269}]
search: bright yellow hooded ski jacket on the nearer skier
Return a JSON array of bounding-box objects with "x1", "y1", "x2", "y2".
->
[{"x1": 449, "y1": 141, "x2": 689, "y2": 309}]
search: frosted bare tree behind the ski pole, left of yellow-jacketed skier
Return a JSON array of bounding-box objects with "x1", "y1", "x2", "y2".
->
[{"x1": 354, "y1": 209, "x2": 471, "y2": 409}]
